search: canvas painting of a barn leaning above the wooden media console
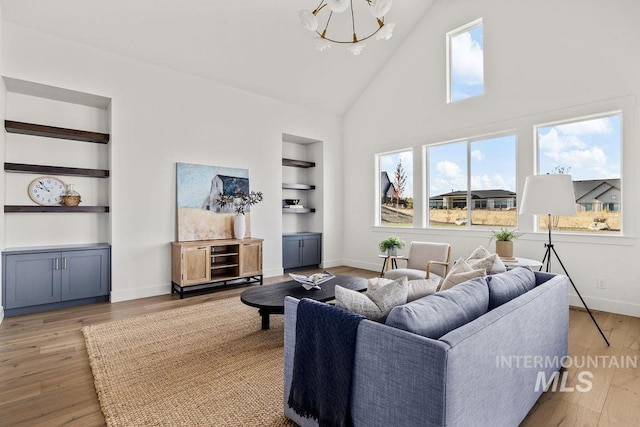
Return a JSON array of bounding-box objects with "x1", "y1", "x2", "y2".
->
[{"x1": 176, "y1": 163, "x2": 258, "y2": 241}]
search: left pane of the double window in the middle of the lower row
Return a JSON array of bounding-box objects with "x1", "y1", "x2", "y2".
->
[{"x1": 427, "y1": 142, "x2": 467, "y2": 227}]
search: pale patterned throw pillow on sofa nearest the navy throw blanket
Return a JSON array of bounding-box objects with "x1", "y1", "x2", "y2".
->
[{"x1": 335, "y1": 277, "x2": 408, "y2": 322}]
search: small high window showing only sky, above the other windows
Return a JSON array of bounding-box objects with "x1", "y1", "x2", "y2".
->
[{"x1": 447, "y1": 19, "x2": 484, "y2": 102}]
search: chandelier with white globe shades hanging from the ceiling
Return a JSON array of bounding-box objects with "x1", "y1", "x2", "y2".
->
[{"x1": 298, "y1": 0, "x2": 396, "y2": 55}]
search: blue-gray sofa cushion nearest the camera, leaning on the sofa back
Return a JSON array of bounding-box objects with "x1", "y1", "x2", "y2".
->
[{"x1": 386, "y1": 277, "x2": 489, "y2": 339}]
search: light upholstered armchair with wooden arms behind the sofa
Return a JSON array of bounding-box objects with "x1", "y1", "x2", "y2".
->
[{"x1": 384, "y1": 242, "x2": 451, "y2": 280}]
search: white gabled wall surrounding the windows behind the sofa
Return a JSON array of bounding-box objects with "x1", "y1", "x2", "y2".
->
[{"x1": 343, "y1": 0, "x2": 640, "y2": 316}]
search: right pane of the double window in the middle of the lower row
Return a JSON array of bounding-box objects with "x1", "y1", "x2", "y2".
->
[{"x1": 469, "y1": 135, "x2": 518, "y2": 227}]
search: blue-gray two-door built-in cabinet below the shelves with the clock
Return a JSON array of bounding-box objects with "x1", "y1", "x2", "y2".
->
[{"x1": 2, "y1": 243, "x2": 111, "y2": 316}]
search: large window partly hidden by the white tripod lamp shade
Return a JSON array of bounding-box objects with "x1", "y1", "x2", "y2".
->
[{"x1": 536, "y1": 113, "x2": 622, "y2": 233}]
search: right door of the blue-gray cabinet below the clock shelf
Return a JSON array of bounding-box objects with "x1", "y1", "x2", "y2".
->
[{"x1": 60, "y1": 249, "x2": 110, "y2": 301}]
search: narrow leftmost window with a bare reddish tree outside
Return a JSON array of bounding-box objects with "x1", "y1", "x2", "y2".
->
[{"x1": 378, "y1": 150, "x2": 413, "y2": 227}]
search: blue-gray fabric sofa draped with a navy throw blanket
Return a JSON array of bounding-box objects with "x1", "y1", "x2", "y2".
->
[{"x1": 284, "y1": 272, "x2": 569, "y2": 427}]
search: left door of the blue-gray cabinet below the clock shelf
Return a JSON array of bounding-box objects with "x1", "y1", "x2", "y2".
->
[{"x1": 4, "y1": 252, "x2": 61, "y2": 309}]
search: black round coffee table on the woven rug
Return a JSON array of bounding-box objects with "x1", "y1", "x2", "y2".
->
[{"x1": 240, "y1": 276, "x2": 368, "y2": 329}]
